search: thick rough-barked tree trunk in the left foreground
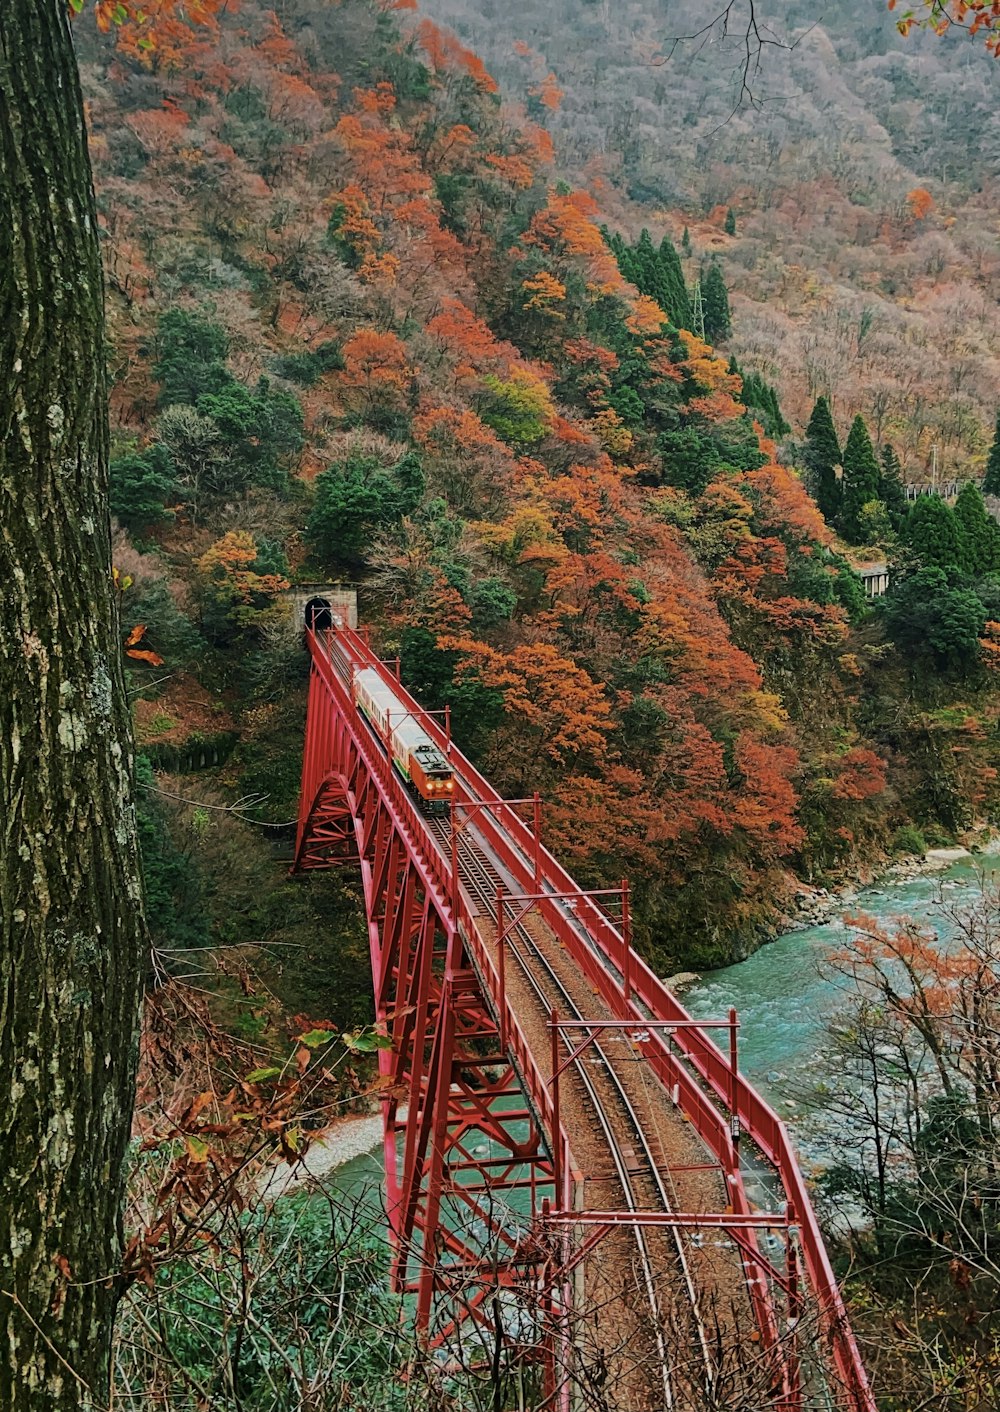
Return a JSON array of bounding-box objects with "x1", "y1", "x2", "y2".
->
[{"x1": 0, "y1": 0, "x2": 145, "y2": 1412}]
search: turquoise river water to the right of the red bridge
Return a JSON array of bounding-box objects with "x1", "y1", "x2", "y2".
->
[{"x1": 682, "y1": 854, "x2": 1000, "y2": 1121}]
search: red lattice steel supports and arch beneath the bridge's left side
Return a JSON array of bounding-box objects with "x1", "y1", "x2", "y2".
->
[{"x1": 294, "y1": 638, "x2": 552, "y2": 1346}]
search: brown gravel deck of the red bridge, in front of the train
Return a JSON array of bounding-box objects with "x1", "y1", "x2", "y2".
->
[{"x1": 428, "y1": 813, "x2": 751, "y2": 1412}]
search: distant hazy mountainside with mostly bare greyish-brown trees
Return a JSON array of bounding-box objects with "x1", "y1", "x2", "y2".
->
[{"x1": 415, "y1": 0, "x2": 1000, "y2": 479}]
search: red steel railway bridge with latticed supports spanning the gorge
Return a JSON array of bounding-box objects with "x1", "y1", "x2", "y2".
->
[{"x1": 295, "y1": 626, "x2": 876, "y2": 1412}]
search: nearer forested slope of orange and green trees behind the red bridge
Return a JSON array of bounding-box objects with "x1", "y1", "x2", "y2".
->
[{"x1": 79, "y1": 0, "x2": 1000, "y2": 994}]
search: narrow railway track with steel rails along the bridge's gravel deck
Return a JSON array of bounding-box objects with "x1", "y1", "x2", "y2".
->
[{"x1": 427, "y1": 819, "x2": 718, "y2": 1412}]
